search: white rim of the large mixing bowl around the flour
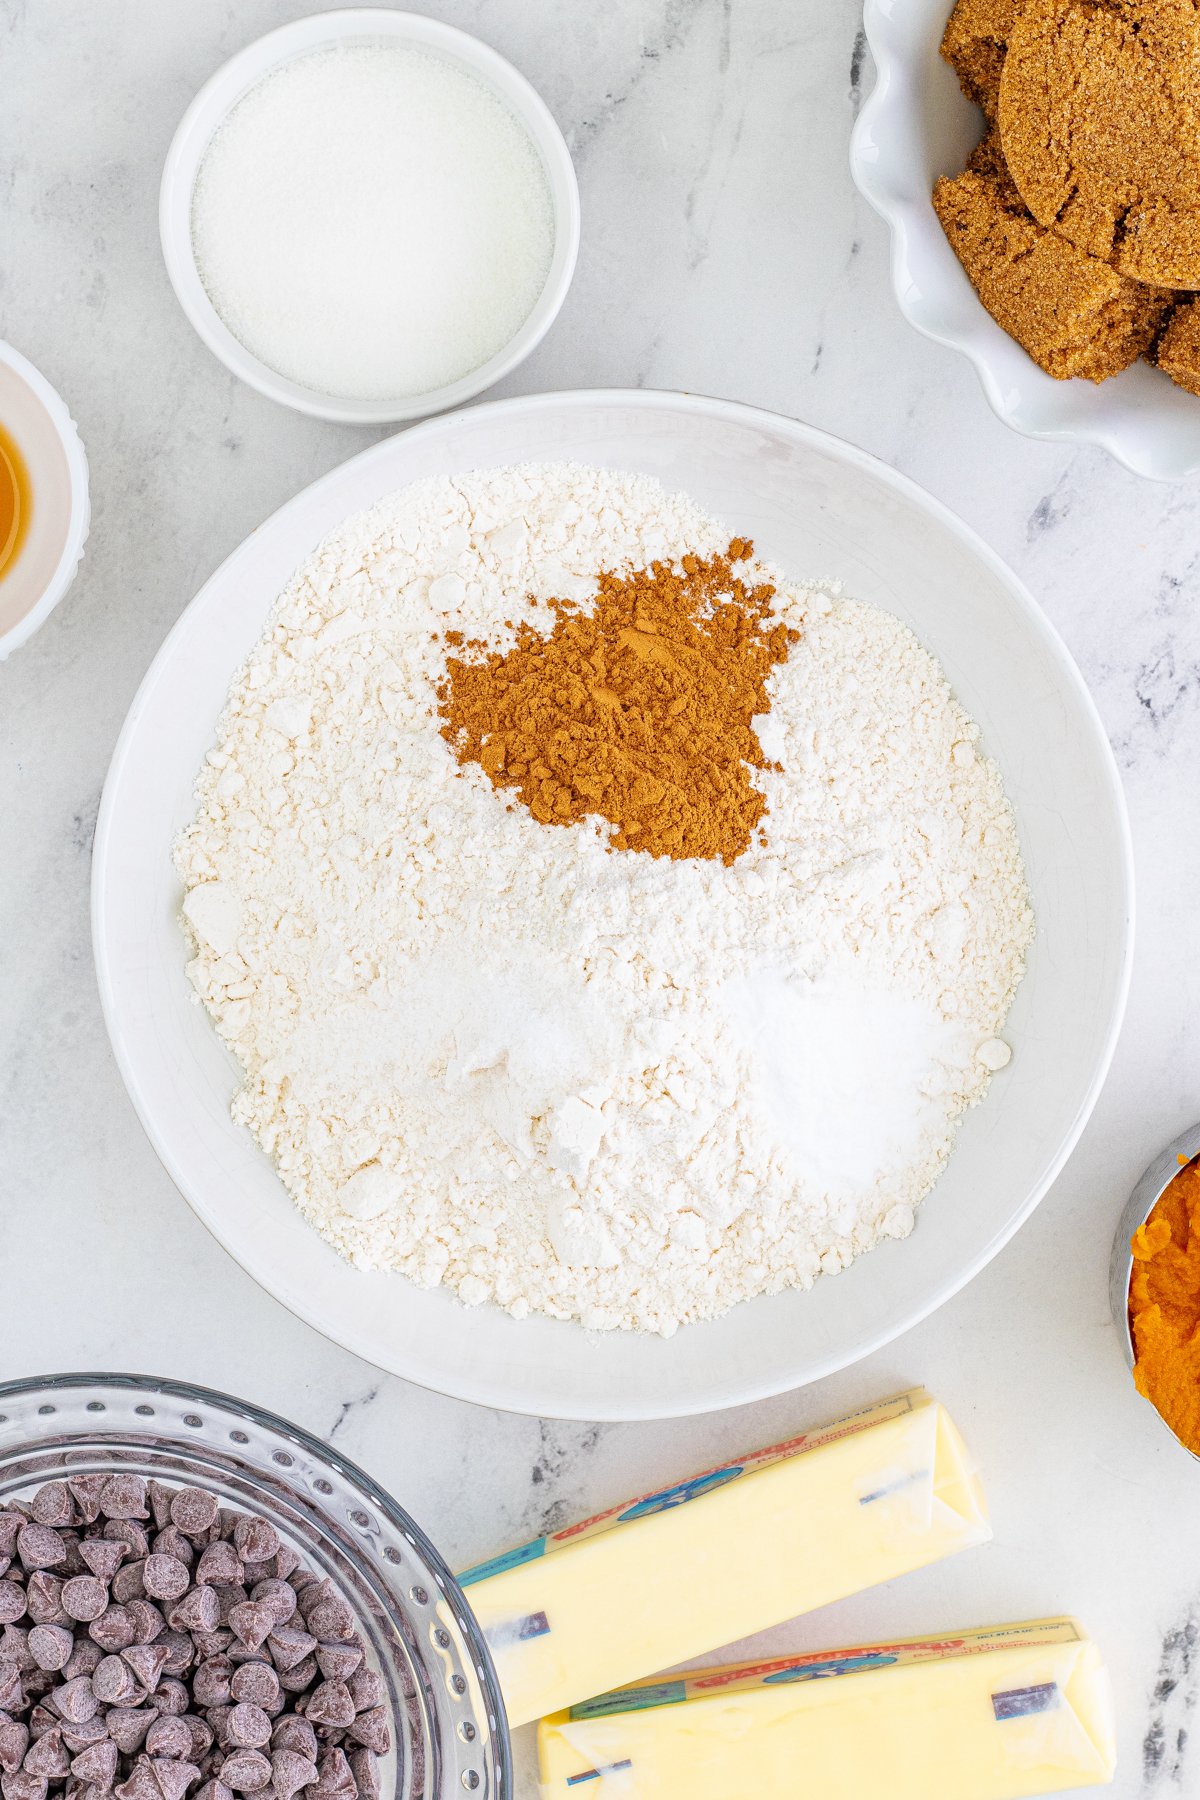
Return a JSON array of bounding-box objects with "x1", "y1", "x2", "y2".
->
[{"x1": 92, "y1": 389, "x2": 1135, "y2": 1424}]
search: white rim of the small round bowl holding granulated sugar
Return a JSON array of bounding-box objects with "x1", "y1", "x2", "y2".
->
[{"x1": 158, "y1": 7, "x2": 579, "y2": 425}]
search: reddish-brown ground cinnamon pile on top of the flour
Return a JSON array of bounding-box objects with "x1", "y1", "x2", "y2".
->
[{"x1": 439, "y1": 538, "x2": 799, "y2": 864}]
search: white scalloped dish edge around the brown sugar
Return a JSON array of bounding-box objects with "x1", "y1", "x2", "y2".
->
[{"x1": 849, "y1": 0, "x2": 1200, "y2": 481}]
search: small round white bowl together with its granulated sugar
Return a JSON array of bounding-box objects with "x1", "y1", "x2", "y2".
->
[{"x1": 158, "y1": 7, "x2": 579, "y2": 425}]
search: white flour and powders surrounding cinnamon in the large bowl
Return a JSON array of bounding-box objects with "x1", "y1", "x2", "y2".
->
[{"x1": 176, "y1": 464, "x2": 1033, "y2": 1332}]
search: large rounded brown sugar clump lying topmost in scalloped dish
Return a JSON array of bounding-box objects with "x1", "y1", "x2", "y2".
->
[{"x1": 999, "y1": 0, "x2": 1200, "y2": 288}]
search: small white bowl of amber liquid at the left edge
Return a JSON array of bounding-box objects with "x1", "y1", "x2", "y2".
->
[{"x1": 0, "y1": 342, "x2": 90, "y2": 662}]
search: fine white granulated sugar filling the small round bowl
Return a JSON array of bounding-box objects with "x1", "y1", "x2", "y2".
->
[{"x1": 193, "y1": 43, "x2": 554, "y2": 400}]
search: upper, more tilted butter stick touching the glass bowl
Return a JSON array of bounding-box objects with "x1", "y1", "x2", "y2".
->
[{"x1": 459, "y1": 1390, "x2": 991, "y2": 1726}]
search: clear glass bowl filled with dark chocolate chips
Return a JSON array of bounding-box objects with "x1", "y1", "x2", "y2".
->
[{"x1": 0, "y1": 1375, "x2": 511, "y2": 1800}]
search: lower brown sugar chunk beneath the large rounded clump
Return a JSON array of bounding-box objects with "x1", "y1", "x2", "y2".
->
[{"x1": 934, "y1": 133, "x2": 1173, "y2": 382}]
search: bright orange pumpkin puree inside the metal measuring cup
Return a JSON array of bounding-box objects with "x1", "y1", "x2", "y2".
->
[{"x1": 1130, "y1": 1157, "x2": 1200, "y2": 1456}]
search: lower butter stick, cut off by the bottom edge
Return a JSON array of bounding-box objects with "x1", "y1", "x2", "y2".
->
[{"x1": 538, "y1": 1618, "x2": 1115, "y2": 1800}]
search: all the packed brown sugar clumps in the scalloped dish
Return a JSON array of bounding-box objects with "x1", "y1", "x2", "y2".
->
[{"x1": 934, "y1": 0, "x2": 1200, "y2": 385}]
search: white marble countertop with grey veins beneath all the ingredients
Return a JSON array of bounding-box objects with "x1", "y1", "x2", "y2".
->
[{"x1": 0, "y1": 0, "x2": 1200, "y2": 1800}]
